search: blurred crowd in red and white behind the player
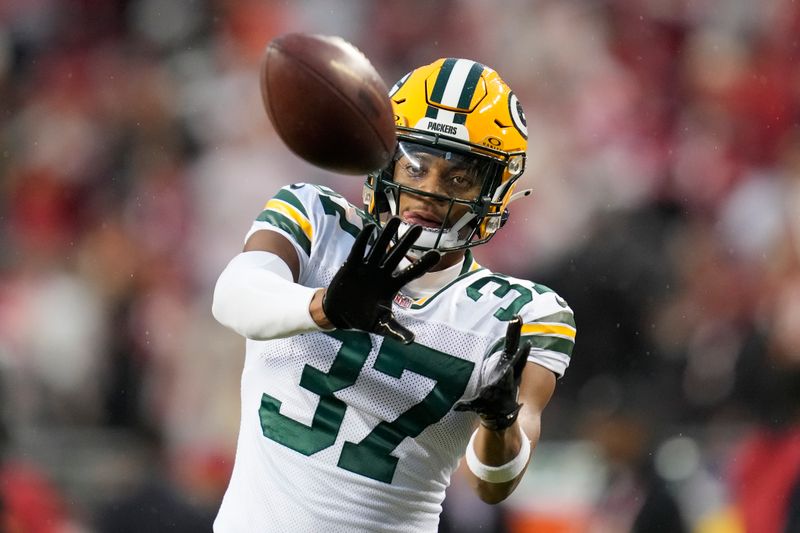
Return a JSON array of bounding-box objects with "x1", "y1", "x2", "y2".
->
[{"x1": 0, "y1": 0, "x2": 800, "y2": 533}]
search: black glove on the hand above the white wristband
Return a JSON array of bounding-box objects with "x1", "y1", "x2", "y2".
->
[{"x1": 453, "y1": 315, "x2": 531, "y2": 431}]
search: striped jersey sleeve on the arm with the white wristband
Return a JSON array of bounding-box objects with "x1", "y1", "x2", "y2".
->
[{"x1": 521, "y1": 289, "x2": 576, "y2": 377}]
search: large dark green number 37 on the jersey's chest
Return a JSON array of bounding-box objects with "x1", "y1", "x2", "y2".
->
[{"x1": 258, "y1": 330, "x2": 474, "y2": 483}]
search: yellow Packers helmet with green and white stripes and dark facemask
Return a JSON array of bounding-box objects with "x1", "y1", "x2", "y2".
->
[{"x1": 363, "y1": 58, "x2": 530, "y2": 251}]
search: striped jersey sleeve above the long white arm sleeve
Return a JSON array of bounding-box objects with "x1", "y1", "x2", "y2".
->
[{"x1": 245, "y1": 183, "x2": 319, "y2": 275}]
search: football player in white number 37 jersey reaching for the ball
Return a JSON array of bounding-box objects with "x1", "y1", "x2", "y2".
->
[{"x1": 213, "y1": 58, "x2": 575, "y2": 533}]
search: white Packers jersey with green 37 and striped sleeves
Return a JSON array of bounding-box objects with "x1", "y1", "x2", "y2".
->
[{"x1": 214, "y1": 184, "x2": 575, "y2": 533}]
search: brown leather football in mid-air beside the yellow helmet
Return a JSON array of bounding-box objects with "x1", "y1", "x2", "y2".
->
[{"x1": 261, "y1": 33, "x2": 397, "y2": 175}]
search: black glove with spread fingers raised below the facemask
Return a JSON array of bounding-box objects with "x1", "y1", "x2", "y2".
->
[{"x1": 322, "y1": 217, "x2": 439, "y2": 344}]
